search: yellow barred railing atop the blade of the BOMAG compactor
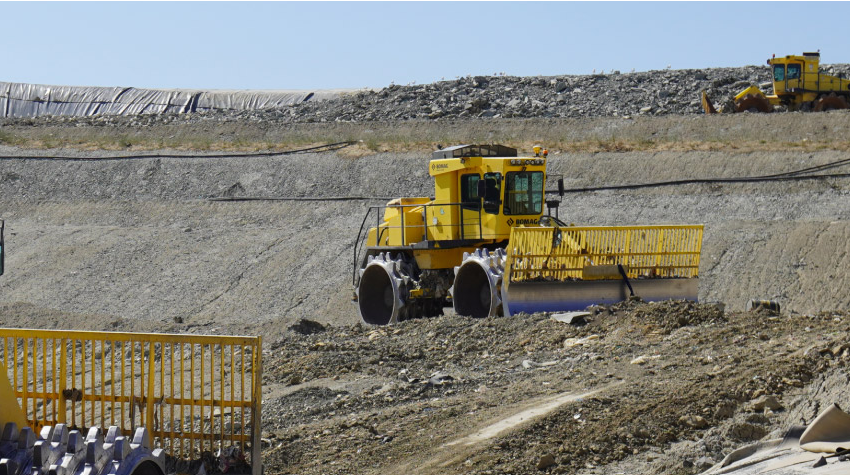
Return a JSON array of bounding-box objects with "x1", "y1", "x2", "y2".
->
[{"x1": 506, "y1": 225, "x2": 703, "y2": 282}]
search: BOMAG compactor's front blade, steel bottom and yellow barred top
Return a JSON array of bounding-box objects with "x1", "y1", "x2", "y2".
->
[{"x1": 501, "y1": 225, "x2": 703, "y2": 315}]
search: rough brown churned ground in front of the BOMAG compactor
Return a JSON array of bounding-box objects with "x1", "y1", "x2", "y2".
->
[{"x1": 258, "y1": 302, "x2": 847, "y2": 474}]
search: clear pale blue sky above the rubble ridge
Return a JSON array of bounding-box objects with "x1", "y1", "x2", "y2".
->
[{"x1": 0, "y1": 2, "x2": 850, "y2": 89}]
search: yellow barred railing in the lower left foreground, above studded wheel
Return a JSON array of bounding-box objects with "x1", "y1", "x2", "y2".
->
[{"x1": 0, "y1": 328, "x2": 262, "y2": 474}]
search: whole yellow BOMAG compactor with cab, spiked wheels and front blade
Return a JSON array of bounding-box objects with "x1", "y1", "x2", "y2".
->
[{"x1": 352, "y1": 145, "x2": 703, "y2": 325}]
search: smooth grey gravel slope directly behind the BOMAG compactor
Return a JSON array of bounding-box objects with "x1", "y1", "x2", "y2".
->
[{"x1": 0, "y1": 149, "x2": 850, "y2": 323}]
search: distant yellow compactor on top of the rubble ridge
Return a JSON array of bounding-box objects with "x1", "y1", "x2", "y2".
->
[{"x1": 702, "y1": 53, "x2": 850, "y2": 114}]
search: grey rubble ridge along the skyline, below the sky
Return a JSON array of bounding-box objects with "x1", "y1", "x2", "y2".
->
[{"x1": 0, "y1": 64, "x2": 850, "y2": 130}]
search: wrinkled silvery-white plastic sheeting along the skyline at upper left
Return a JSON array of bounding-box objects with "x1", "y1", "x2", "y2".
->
[{"x1": 0, "y1": 82, "x2": 345, "y2": 117}]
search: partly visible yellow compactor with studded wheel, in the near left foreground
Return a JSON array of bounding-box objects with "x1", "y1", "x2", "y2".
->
[{"x1": 0, "y1": 220, "x2": 262, "y2": 475}]
